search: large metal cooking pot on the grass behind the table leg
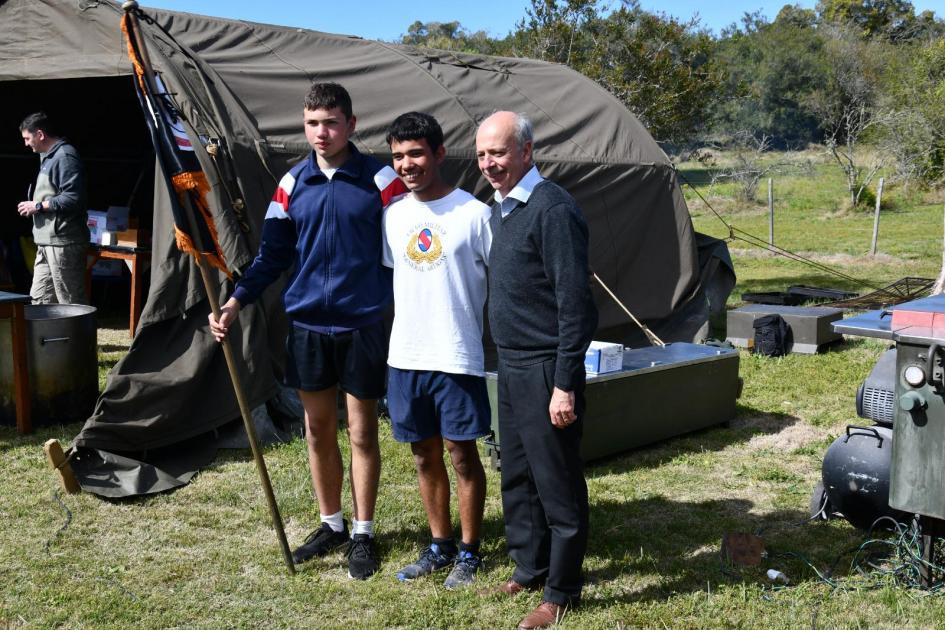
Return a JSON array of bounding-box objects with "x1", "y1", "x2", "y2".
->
[{"x1": 0, "y1": 304, "x2": 98, "y2": 426}]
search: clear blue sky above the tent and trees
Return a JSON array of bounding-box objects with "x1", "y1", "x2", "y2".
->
[{"x1": 139, "y1": 0, "x2": 945, "y2": 41}]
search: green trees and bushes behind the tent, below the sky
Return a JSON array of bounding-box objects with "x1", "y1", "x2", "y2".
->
[{"x1": 401, "y1": 0, "x2": 945, "y2": 191}]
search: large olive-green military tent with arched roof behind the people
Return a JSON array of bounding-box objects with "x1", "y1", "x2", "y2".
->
[{"x1": 0, "y1": 0, "x2": 734, "y2": 494}]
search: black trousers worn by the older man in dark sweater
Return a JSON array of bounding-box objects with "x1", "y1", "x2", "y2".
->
[{"x1": 498, "y1": 352, "x2": 588, "y2": 606}]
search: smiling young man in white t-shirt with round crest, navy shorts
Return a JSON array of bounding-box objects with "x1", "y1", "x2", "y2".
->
[{"x1": 383, "y1": 112, "x2": 492, "y2": 588}]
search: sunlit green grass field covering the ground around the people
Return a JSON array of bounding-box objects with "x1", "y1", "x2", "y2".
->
[{"x1": 0, "y1": 154, "x2": 945, "y2": 628}]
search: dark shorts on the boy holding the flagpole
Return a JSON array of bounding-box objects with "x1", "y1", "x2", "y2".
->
[{"x1": 285, "y1": 322, "x2": 387, "y2": 400}]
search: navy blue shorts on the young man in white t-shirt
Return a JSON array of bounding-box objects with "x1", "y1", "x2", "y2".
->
[{"x1": 387, "y1": 367, "x2": 492, "y2": 442}]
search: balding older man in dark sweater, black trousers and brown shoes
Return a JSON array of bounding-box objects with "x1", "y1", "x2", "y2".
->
[{"x1": 476, "y1": 112, "x2": 597, "y2": 628}]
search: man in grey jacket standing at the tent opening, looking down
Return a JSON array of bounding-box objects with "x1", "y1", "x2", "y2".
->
[{"x1": 16, "y1": 112, "x2": 89, "y2": 304}]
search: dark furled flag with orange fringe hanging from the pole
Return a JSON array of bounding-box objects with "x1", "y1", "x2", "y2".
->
[{"x1": 121, "y1": 12, "x2": 230, "y2": 276}]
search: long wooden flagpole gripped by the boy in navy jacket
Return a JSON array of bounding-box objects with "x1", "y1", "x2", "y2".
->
[{"x1": 122, "y1": 0, "x2": 295, "y2": 574}]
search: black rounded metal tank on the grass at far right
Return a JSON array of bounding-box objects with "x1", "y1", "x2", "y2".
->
[{"x1": 821, "y1": 426, "x2": 908, "y2": 529}]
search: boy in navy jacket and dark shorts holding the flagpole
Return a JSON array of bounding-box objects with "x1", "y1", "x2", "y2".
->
[{"x1": 210, "y1": 83, "x2": 406, "y2": 579}]
